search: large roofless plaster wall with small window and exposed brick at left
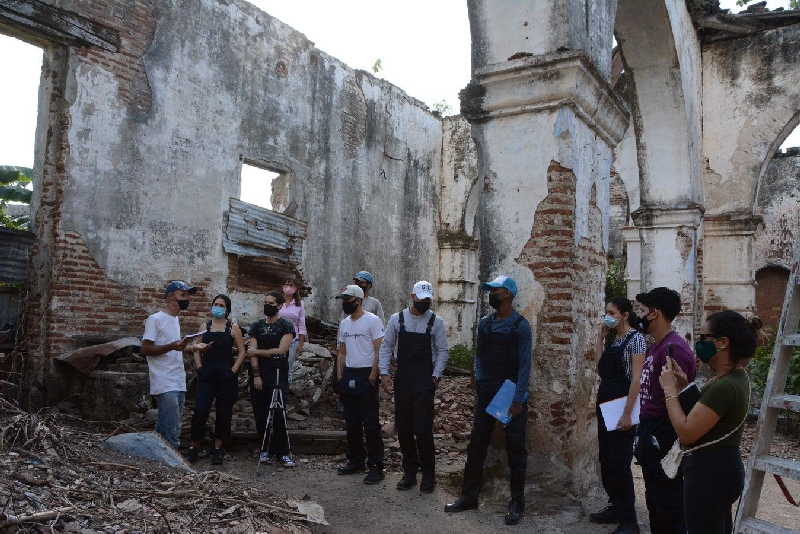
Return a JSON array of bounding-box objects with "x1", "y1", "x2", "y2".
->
[{"x1": 15, "y1": 0, "x2": 442, "y2": 402}]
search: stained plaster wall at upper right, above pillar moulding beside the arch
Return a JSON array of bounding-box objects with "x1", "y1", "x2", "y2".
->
[{"x1": 703, "y1": 25, "x2": 800, "y2": 215}]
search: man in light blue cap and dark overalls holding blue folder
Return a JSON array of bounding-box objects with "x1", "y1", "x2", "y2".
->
[{"x1": 444, "y1": 276, "x2": 533, "y2": 525}]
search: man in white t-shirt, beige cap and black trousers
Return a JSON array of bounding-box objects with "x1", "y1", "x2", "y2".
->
[{"x1": 336, "y1": 285, "x2": 384, "y2": 484}]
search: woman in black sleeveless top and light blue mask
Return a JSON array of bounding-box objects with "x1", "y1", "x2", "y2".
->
[{"x1": 186, "y1": 295, "x2": 245, "y2": 465}]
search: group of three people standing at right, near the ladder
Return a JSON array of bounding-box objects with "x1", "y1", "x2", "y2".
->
[{"x1": 590, "y1": 287, "x2": 761, "y2": 534}]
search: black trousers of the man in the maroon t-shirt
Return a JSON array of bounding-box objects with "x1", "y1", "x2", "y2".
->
[{"x1": 635, "y1": 417, "x2": 686, "y2": 534}]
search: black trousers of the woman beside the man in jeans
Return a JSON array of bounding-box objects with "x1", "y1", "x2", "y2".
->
[{"x1": 192, "y1": 364, "x2": 239, "y2": 441}]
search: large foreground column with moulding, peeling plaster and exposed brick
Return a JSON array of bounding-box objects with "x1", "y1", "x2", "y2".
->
[{"x1": 461, "y1": 0, "x2": 628, "y2": 499}]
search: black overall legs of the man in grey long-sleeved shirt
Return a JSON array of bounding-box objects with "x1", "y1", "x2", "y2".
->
[{"x1": 394, "y1": 382, "x2": 436, "y2": 475}]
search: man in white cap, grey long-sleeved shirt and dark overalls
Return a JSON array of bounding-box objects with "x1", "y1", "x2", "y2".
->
[{"x1": 380, "y1": 280, "x2": 449, "y2": 493}]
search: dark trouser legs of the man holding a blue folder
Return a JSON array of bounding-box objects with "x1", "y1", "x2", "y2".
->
[{"x1": 461, "y1": 386, "x2": 528, "y2": 502}]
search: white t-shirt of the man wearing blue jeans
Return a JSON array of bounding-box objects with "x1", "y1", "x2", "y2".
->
[{"x1": 142, "y1": 311, "x2": 186, "y2": 395}]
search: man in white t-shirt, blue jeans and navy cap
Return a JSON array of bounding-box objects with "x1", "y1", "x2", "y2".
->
[{"x1": 142, "y1": 280, "x2": 197, "y2": 449}]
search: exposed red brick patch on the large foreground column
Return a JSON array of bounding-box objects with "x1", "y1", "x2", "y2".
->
[{"x1": 518, "y1": 162, "x2": 606, "y2": 496}]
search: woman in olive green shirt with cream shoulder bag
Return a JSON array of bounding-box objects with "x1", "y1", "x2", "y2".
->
[{"x1": 660, "y1": 311, "x2": 761, "y2": 534}]
